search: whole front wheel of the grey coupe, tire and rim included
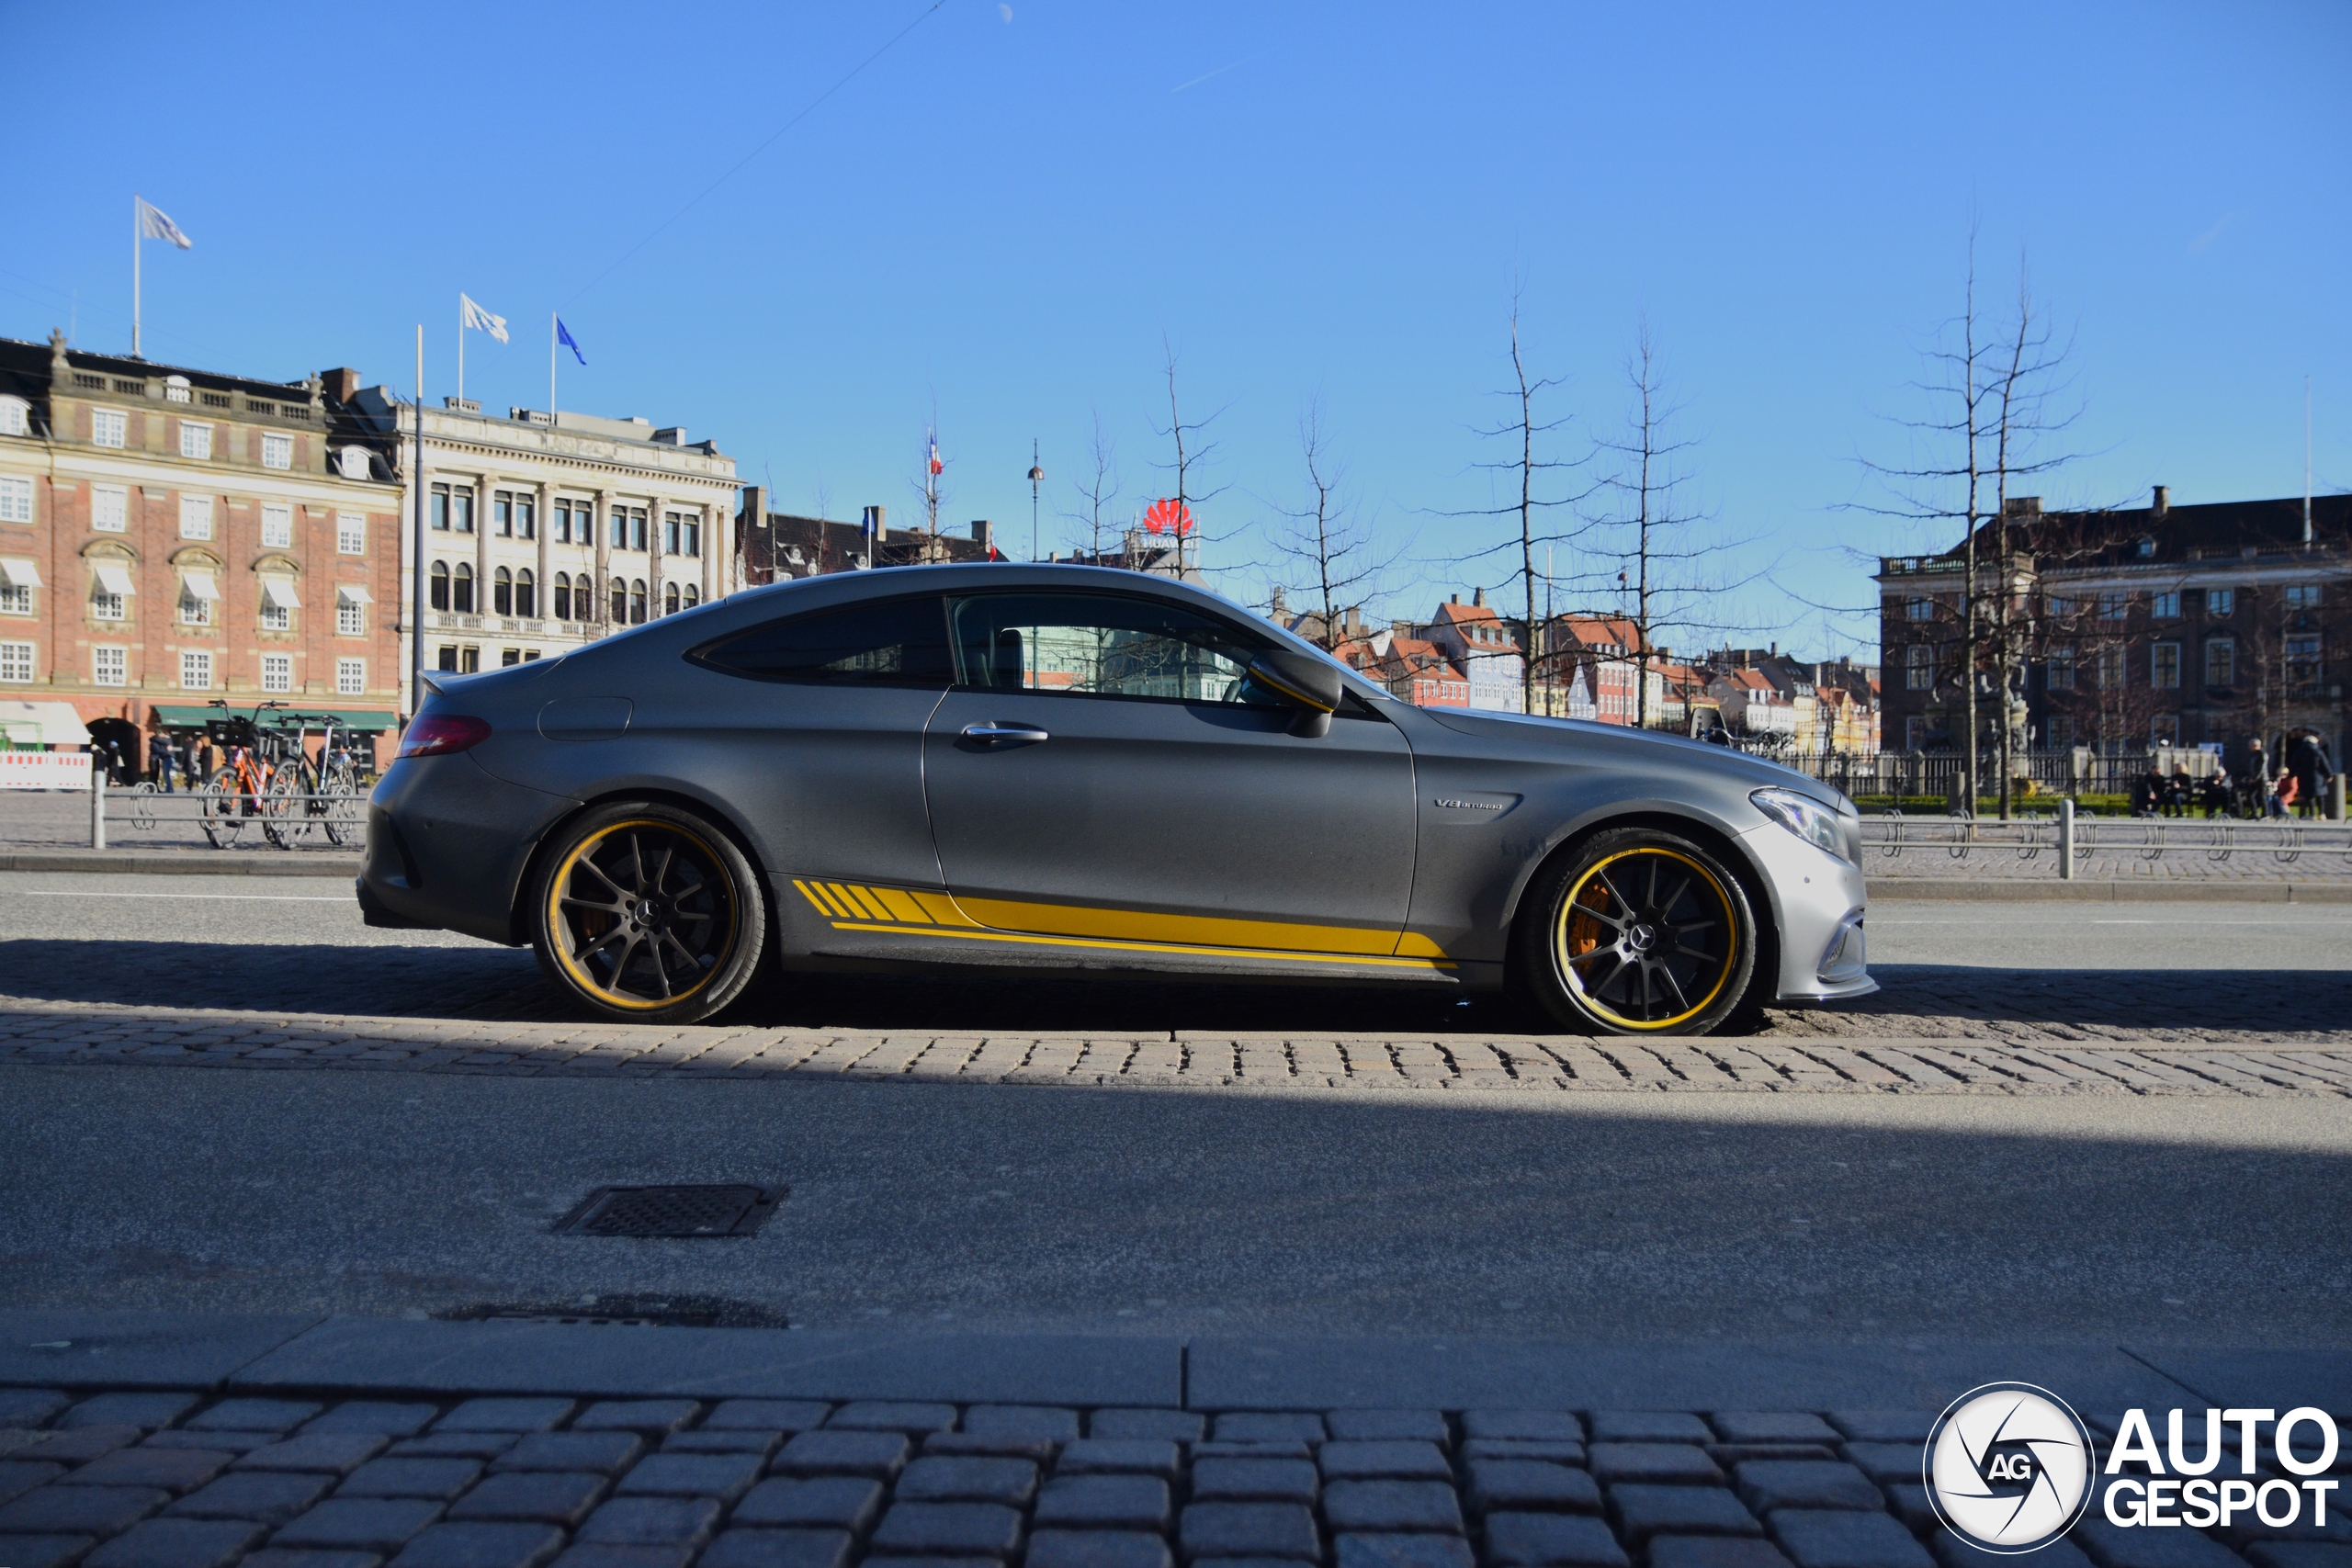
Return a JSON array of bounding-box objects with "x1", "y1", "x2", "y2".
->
[{"x1": 1512, "y1": 828, "x2": 1757, "y2": 1034}]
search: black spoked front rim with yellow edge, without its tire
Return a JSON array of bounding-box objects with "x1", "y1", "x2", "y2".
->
[{"x1": 1553, "y1": 846, "x2": 1738, "y2": 1032}]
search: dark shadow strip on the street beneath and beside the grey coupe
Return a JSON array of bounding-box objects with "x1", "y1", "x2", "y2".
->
[{"x1": 0, "y1": 938, "x2": 2352, "y2": 1039}]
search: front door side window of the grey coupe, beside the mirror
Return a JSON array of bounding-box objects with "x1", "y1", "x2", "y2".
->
[{"x1": 948, "y1": 592, "x2": 1268, "y2": 703}]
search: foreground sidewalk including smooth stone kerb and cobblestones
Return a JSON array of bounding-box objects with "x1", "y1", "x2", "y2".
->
[{"x1": 0, "y1": 1309, "x2": 2352, "y2": 1568}]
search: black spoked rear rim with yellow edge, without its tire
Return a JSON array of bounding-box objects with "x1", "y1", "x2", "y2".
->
[{"x1": 546, "y1": 818, "x2": 741, "y2": 1013}]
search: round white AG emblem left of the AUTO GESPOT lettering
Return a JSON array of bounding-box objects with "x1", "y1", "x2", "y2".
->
[{"x1": 1922, "y1": 1382, "x2": 2093, "y2": 1554}]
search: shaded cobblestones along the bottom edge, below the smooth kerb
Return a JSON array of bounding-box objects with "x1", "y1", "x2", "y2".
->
[{"x1": 0, "y1": 1392, "x2": 2352, "y2": 1568}]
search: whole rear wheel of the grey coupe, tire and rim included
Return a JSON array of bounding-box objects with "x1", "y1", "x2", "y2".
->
[{"x1": 529, "y1": 802, "x2": 767, "y2": 1022}]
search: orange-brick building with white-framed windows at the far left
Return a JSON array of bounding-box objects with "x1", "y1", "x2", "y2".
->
[{"x1": 0, "y1": 332, "x2": 400, "y2": 733}]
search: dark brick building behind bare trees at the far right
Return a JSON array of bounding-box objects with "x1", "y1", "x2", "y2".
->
[{"x1": 1877, "y1": 487, "x2": 2352, "y2": 757}]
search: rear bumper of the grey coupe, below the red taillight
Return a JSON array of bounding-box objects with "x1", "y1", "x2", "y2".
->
[{"x1": 357, "y1": 755, "x2": 574, "y2": 947}]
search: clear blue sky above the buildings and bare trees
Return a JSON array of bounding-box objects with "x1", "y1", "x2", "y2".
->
[{"x1": 0, "y1": 0, "x2": 2352, "y2": 653}]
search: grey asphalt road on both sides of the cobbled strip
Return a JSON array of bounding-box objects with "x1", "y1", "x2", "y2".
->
[{"x1": 0, "y1": 874, "x2": 2352, "y2": 1345}]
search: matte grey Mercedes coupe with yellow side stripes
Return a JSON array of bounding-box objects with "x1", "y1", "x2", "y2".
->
[{"x1": 357, "y1": 564, "x2": 1877, "y2": 1034}]
